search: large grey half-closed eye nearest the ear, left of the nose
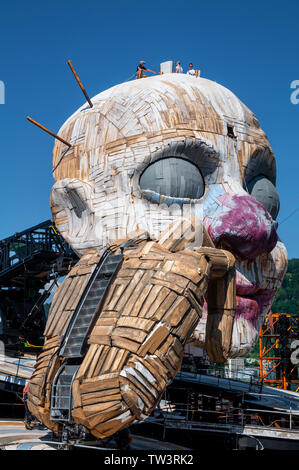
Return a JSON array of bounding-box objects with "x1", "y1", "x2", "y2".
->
[{"x1": 139, "y1": 157, "x2": 204, "y2": 202}]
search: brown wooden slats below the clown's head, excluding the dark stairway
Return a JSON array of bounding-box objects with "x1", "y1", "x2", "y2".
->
[{"x1": 31, "y1": 219, "x2": 235, "y2": 437}]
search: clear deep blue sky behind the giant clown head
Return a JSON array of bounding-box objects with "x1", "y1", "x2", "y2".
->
[{"x1": 0, "y1": 0, "x2": 299, "y2": 258}]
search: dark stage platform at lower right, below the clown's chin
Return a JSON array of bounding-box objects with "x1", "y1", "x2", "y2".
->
[{"x1": 132, "y1": 364, "x2": 299, "y2": 451}]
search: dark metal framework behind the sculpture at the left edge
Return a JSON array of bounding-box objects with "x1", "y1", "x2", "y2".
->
[{"x1": 0, "y1": 220, "x2": 78, "y2": 347}]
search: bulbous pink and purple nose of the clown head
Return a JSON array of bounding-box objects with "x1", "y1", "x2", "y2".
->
[{"x1": 204, "y1": 194, "x2": 278, "y2": 260}]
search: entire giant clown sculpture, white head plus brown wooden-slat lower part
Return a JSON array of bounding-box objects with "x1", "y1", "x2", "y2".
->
[{"x1": 28, "y1": 74, "x2": 287, "y2": 438}]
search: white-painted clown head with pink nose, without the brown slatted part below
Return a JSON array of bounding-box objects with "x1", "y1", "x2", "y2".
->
[{"x1": 52, "y1": 74, "x2": 287, "y2": 357}]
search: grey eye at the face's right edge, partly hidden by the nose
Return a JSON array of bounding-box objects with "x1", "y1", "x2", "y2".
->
[{"x1": 247, "y1": 175, "x2": 280, "y2": 220}]
